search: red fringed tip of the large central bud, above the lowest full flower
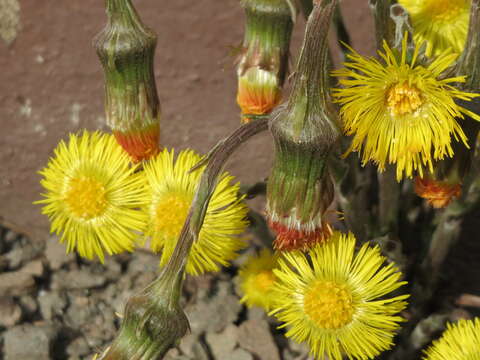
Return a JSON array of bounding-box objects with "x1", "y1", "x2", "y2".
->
[{"x1": 268, "y1": 221, "x2": 333, "y2": 251}]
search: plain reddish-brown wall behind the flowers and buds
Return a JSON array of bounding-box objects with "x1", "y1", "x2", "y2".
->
[{"x1": 0, "y1": 0, "x2": 374, "y2": 240}]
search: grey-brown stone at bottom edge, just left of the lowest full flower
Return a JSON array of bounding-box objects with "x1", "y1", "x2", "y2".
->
[{"x1": 238, "y1": 320, "x2": 280, "y2": 360}]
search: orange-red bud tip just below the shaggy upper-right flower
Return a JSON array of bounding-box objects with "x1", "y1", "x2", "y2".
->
[{"x1": 415, "y1": 176, "x2": 462, "y2": 209}]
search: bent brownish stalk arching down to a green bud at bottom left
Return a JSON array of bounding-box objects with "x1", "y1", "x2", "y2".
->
[{"x1": 99, "y1": 119, "x2": 267, "y2": 360}]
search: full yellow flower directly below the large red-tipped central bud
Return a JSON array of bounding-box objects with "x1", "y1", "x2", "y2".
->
[{"x1": 271, "y1": 232, "x2": 408, "y2": 360}]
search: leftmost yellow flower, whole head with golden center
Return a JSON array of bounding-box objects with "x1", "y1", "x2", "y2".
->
[{"x1": 36, "y1": 131, "x2": 146, "y2": 262}]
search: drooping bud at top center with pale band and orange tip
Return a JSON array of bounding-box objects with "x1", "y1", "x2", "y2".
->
[{"x1": 237, "y1": 0, "x2": 294, "y2": 122}]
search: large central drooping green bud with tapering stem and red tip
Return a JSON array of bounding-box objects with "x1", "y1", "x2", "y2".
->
[{"x1": 267, "y1": 1, "x2": 340, "y2": 250}]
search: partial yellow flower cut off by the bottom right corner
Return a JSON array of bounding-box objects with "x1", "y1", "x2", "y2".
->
[{"x1": 423, "y1": 318, "x2": 480, "y2": 360}]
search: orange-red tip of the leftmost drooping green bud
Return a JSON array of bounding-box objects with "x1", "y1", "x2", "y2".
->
[{"x1": 113, "y1": 126, "x2": 160, "y2": 162}]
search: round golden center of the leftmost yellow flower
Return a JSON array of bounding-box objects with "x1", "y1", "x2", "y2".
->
[{"x1": 65, "y1": 176, "x2": 107, "y2": 220}]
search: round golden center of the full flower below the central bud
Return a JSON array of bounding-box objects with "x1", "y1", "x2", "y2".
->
[{"x1": 303, "y1": 281, "x2": 354, "y2": 329}]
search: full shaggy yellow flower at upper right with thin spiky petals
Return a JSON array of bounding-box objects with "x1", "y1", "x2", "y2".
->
[{"x1": 333, "y1": 36, "x2": 480, "y2": 180}]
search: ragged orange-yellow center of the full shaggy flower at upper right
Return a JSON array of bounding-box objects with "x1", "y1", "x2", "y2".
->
[{"x1": 387, "y1": 82, "x2": 423, "y2": 115}]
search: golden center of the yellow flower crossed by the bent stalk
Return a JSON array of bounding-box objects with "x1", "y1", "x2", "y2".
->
[{"x1": 155, "y1": 194, "x2": 191, "y2": 238}]
